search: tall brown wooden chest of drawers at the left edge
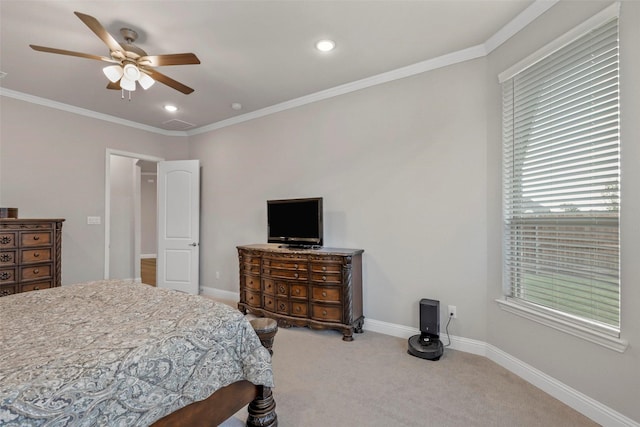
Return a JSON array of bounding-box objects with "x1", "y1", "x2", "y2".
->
[{"x1": 0, "y1": 218, "x2": 64, "y2": 297}]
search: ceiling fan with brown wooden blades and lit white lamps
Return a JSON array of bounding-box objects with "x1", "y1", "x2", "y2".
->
[{"x1": 29, "y1": 12, "x2": 200, "y2": 95}]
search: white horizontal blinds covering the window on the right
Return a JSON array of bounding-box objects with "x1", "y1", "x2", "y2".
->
[{"x1": 502, "y1": 18, "x2": 620, "y2": 336}]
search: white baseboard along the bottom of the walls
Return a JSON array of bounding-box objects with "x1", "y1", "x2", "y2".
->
[{"x1": 200, "y1": 287, "x2": 640, "y2": 427}]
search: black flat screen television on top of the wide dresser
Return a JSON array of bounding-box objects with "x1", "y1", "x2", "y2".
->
[{"x1": 267, "y1": 197, "x2": 323, "y2": 247}]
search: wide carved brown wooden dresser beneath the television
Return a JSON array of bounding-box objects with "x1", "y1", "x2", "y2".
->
[{"x1": 237, "y1": 244, "x2": 364, "y2": 341}]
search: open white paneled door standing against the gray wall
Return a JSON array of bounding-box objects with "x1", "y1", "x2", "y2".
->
[{"x1": 156, "y1": 160, "x2": 200, "y2": 295}]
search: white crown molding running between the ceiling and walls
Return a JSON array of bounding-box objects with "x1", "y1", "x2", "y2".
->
[{"x1": 0, "y1": 0, "x2": 559, "y2": 137}]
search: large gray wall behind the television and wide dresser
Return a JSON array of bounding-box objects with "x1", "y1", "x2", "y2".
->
[{"x1": 189, "y1": 59, "x2": 487, "y2": 341}]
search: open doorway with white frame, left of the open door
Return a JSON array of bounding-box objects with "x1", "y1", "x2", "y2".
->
[{"x1": 104, "y1": 149, "x2": 164, "y2": 282}]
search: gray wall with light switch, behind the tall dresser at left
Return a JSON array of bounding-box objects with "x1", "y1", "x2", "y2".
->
[{"x1": 0, "y1": 96, "x2": 188, "y2": 284}]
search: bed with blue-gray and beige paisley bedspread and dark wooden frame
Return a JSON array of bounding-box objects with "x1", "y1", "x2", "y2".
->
[{"x1": 0, "y1": 280, "x2": 277, "y2": 427}]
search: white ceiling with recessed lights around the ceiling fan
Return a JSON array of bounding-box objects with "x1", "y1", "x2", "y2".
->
[{"x1": 0, "y1": 0, "x2": 535, "y2": 131}]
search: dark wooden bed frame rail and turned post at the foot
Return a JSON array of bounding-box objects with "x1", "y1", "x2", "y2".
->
[{"x1": 152, "y1": 330, "x2": 278, "y2": 427}]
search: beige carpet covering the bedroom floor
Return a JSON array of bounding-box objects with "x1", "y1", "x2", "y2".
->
[{"x1": 224, "y1": 310, "x2": 597, "y2": 427}]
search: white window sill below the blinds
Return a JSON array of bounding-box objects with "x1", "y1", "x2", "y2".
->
[{"x1": 496, "y1": 299, "x2": 629, "y2": 353}]
